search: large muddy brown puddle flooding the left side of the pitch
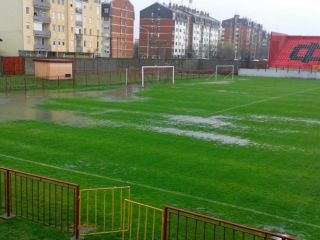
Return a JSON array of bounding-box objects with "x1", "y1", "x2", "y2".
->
[{"x1": 0, "y1": 87, "x2": 141, "y2": 126}]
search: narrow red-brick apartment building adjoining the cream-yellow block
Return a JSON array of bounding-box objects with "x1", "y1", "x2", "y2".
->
[{"x1": 102, "y1": 0, "x2": 135, "y2": 58}]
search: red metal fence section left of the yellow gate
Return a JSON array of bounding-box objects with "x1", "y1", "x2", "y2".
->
[{"x1": 0, "y1": 168, "x2": 80, "y2": 239}]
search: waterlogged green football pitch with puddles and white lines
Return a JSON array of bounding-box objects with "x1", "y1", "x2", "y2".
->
[{"x1": 0, "y1": 77, "x2": 320, "y2": 240}]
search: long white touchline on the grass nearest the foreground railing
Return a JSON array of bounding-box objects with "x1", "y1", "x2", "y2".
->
[{"x1": 0, "y1": 154, "x2": 320, "y2": 229}]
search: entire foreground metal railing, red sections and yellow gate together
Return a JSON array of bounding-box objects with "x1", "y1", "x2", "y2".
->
[{"x1": 0, "y1": 168, "x2": 295, "y2": 240}]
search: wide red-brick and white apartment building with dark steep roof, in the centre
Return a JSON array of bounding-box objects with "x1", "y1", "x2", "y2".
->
[{"x1": 139, "y1": 3, "x2": 220, "y2": 58}]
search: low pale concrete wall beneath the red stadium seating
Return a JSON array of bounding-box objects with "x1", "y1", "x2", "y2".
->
[{"x1": 239, "y1": 68, "x2": 320, "y2": 80}]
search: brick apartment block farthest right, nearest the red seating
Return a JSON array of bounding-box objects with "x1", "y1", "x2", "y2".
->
[{"x1": 222, "y1": 15, "x2": 269, "y2": 59}]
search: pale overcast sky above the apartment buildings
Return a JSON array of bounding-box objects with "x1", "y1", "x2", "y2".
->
[{"x1": 131, "y1": 0, "x2": 320, "y2": 38}]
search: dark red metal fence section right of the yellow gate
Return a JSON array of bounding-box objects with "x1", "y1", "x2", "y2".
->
[{"x1": 163, "y1": 207, "x2": 294, "y2": 240}]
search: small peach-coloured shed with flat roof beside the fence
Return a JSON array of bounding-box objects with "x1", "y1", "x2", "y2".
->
[{"x1": 34, "y1": 59, "x2": 73, "y2": 80}]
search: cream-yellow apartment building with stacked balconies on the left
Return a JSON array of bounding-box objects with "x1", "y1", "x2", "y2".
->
[{"x1": 0, "y1": 0, "x2": 101, "y2": 57}]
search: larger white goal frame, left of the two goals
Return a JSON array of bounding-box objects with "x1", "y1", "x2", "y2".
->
[{"x1": 141, "y1": 66, "x2": 175, "y2": 87}]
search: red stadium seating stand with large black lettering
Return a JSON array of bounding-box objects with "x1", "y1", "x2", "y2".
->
[{"x1": 269, "y1": 33, "x2": 320, "y2": 70}]
